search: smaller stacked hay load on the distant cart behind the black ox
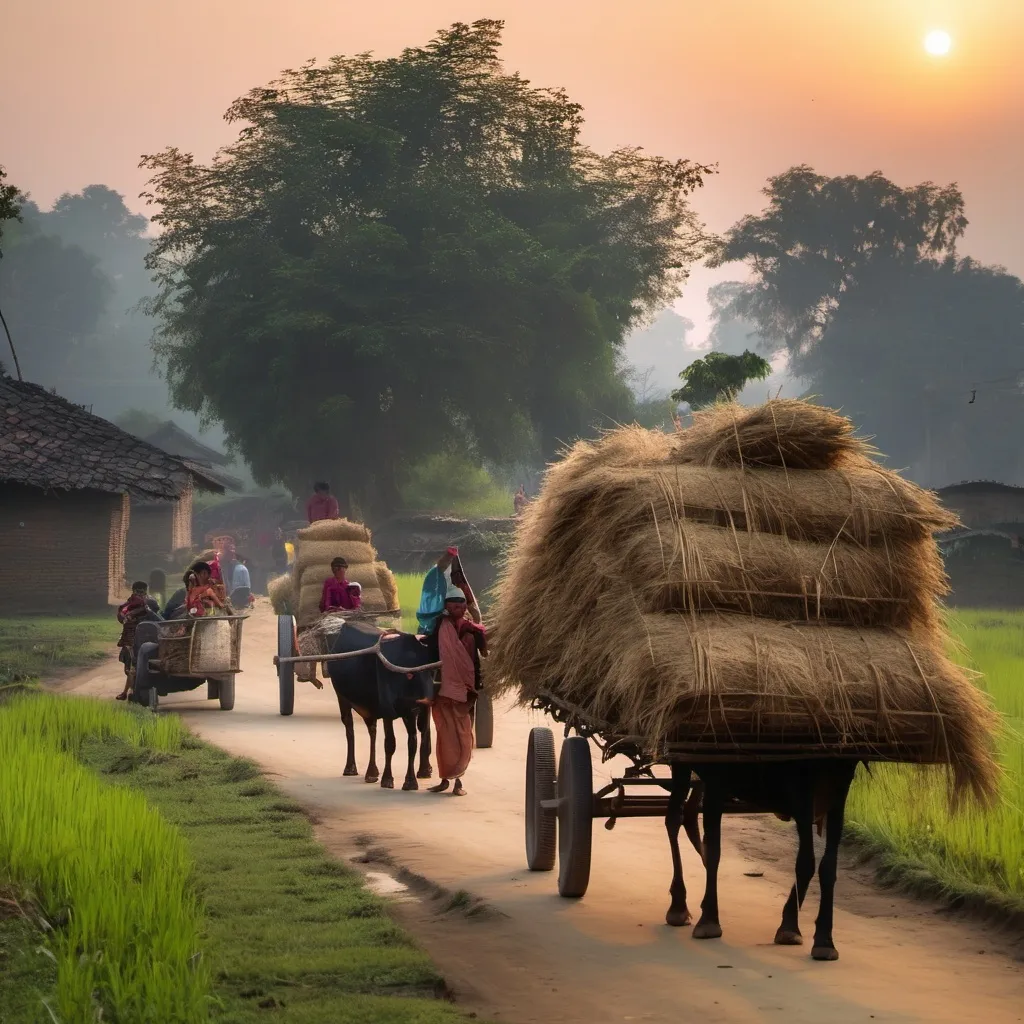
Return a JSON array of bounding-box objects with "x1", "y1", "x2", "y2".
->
[{"x1": 267, "y1": 519, "x2": 398, "y2": 630}]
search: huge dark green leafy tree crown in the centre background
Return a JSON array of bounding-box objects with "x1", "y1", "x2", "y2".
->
[{"x1": 144, "y1": 22, "x2": 709, "y2": 507}]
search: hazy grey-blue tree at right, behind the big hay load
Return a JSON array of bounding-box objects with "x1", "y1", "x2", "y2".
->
[{"x1": 716, "y1": 167, "x2": 1024, "y2": 486}]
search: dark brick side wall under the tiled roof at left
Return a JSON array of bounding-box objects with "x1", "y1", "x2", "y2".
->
[{"x1": 0, "y1": 484, "x2": 123, "y2": 615}]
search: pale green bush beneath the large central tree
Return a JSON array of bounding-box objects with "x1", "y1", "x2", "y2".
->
[{"x1": 398, "y1": 453, "x2": 512, "y2": 517}]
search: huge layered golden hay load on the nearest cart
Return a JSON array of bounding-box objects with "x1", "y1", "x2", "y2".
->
[{"x1": 488, "y1": 400, "x2": 997, "y2": 800}]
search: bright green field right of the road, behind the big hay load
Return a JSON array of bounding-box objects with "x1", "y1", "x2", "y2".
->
[{"x1": 849, "y1": 609, "x2": 1024, "y2": 912}]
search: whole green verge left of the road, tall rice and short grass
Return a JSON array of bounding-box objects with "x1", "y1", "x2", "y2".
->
[{"x1": 0, "y1": 693, "x2": 463, "y2": 1024}]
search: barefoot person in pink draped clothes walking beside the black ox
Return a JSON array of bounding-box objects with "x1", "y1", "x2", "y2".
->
[{"x1": 430, "y1": 587, "x2": 487, "y2": 797}]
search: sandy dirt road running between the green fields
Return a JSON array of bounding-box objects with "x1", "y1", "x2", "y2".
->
[{"x1": 62, "y1": 605, "x2": 1024, "y2": 1024}]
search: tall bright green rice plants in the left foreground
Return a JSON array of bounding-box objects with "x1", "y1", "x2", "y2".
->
[{"x1": 0, "y1": 694, "x2": 210, "y2": 1024}]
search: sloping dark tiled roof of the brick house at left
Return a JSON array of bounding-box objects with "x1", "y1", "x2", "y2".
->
[{"x1": 0, "y1": 376, "x2": 223, "y2": 500}]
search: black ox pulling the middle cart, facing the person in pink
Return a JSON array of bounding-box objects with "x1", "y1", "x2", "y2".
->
[{"x1": 327, "y1": 623, "x2": 436, "y2": 790}]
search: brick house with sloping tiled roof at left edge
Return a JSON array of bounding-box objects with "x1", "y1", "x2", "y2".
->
[{"x1": 0, "y1": 376, "x2": 222, "y2": 614}]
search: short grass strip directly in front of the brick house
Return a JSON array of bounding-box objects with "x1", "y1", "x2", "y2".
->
[{"x1": 0, "y1": 610, "x2": 121, "y2": 684}]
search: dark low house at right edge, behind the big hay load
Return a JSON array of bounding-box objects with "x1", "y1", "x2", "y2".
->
[{"x1": 938, "y1": 480, "x2": 1024, "y2": 608}]
